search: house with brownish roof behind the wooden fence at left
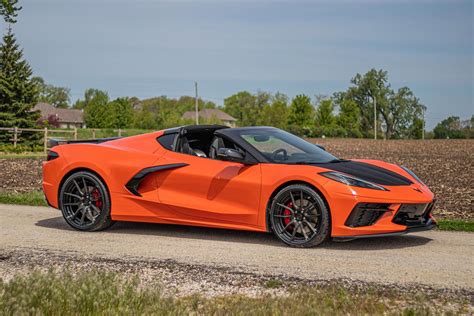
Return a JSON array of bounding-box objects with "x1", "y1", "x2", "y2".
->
[{"x1": 33, "y1": 102, "x2": 86, "y2": 128}]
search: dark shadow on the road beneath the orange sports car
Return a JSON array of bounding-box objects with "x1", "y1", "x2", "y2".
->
[{"x1": 36, "y1": 217, "x2": 432, "y2": 251}]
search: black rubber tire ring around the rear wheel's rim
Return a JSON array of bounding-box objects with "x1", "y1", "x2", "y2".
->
[{"x1": 59, "y1": 171, "x2": 110, "y2": 231}]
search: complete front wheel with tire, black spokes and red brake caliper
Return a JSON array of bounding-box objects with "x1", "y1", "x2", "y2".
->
[{"x1": 269, "y1": 184, "x2": 330, "y2": 248}]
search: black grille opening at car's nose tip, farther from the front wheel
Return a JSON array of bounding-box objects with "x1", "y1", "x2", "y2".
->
[{"x1": 393, "y1": 201, "x2": 434, "y2": 227}]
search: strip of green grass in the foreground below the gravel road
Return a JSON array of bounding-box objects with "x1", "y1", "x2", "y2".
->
[{"x1": 0, "y1": 270, "x2": 469, "y2": 315}]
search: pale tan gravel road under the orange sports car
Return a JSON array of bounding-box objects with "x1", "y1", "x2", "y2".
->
[{"x1": 0, "y1": 204, "x2": 474, "y2": 293}]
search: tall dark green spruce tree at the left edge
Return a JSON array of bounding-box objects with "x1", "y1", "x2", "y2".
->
[{"x1": 0, "y1": 28, "x2": 39, "y2": 142}]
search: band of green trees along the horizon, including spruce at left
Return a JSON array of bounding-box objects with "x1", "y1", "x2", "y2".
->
[{"x1": 0, "y1": 0, "x2": 473, "y2": 142}]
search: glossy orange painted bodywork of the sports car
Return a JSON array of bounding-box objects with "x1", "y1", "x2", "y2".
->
[{"x1": 43, "y1": 131, "x2": 434, "y2": 236}]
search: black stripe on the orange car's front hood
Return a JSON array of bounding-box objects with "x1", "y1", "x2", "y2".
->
[{"x1": 314, "y1": 160, "x2": 413, "y2": 186}]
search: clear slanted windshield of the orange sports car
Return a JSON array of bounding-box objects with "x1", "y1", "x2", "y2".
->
[{"x1": 239, "y1": 128, "x2": 339, "y2": 164}]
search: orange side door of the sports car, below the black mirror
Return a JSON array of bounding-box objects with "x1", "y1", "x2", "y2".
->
[{"x1": 156, "y1": 151, "x2": 261, "y2": 225}]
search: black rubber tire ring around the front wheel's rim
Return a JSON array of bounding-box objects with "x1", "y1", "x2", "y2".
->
[{"x1": 269, "y1": 184, "x2": 331, "y2": 248}]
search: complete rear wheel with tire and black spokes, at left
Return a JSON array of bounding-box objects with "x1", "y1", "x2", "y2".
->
[{"x1": 59, "y1": 171, "x2": 113, "y2": 231}]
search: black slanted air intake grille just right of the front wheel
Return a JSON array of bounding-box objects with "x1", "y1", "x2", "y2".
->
[{"x1": 345, "y1": 203, "x2": 390, "y2": 227}]
